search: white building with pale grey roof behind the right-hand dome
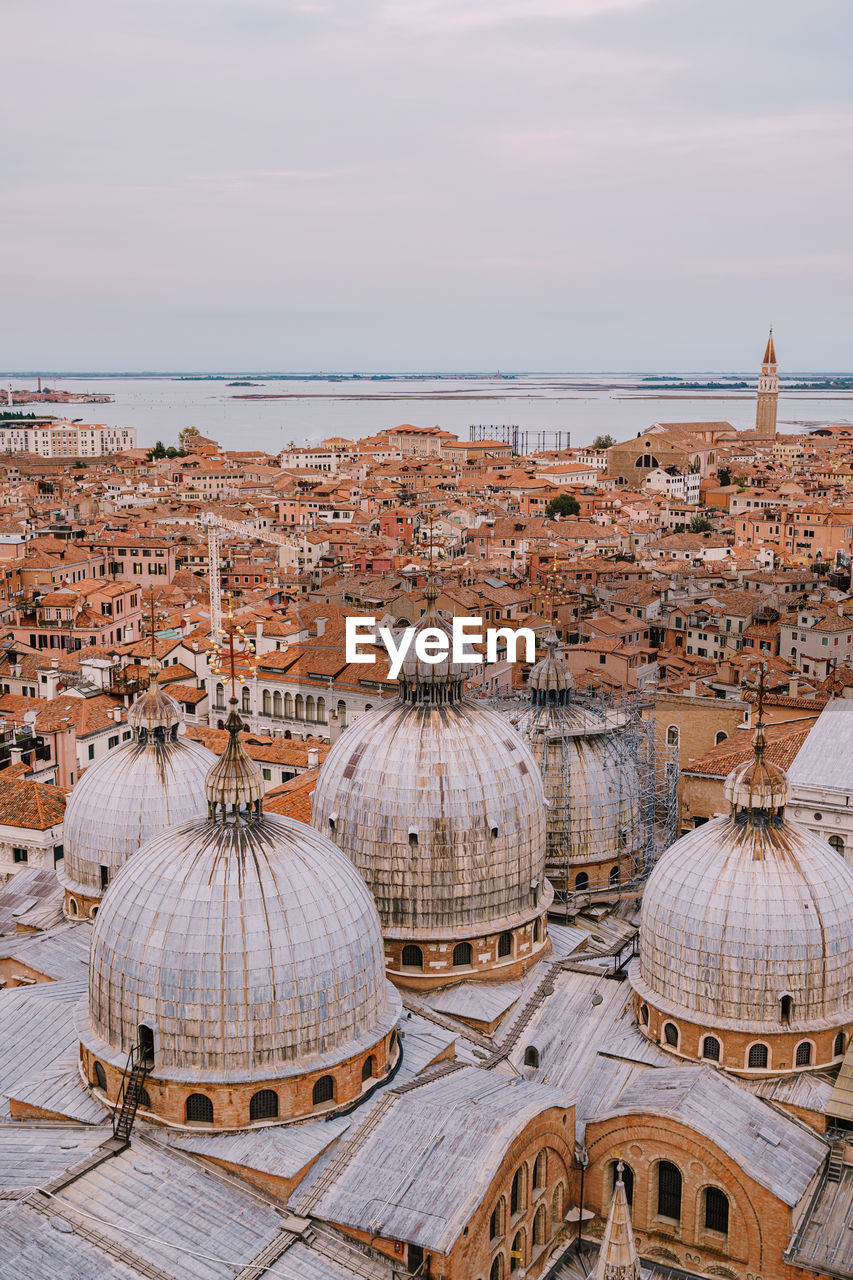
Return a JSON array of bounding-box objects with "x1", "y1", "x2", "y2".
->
[{"x1": 788, "y1": 698, "x2": 853, "y2": 867}]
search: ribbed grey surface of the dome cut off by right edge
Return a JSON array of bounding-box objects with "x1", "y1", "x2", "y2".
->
[{"x1": 630, "y1": 817, "x2": 853, "y2": 1032}]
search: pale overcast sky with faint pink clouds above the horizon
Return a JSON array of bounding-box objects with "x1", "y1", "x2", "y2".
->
[{"x1": 0, "y1": 0, "x2": 853, "y2": 371}]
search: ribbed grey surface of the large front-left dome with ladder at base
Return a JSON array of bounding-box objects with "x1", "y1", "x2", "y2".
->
[{"x1": 81, "y1": 814, "x2": 400, "y2": 1082}]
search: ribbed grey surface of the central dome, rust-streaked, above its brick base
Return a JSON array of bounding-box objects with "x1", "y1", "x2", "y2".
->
[{"x1": 311, "y1": 698, "x2": 551, "y2": 937}]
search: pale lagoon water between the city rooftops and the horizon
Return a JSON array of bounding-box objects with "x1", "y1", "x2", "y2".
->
[{"x1": 0, "y1": 374, "x2": 853, "y2": 453}]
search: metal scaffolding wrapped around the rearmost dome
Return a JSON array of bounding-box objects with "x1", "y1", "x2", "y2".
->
[{"x1": 488, "y1": 686, "x2": 679, "y2": 918}]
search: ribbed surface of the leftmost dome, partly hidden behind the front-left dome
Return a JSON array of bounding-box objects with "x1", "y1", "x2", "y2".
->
[{"x1": 59, "y1": 732, "x2": 216, "y2": 895}]
